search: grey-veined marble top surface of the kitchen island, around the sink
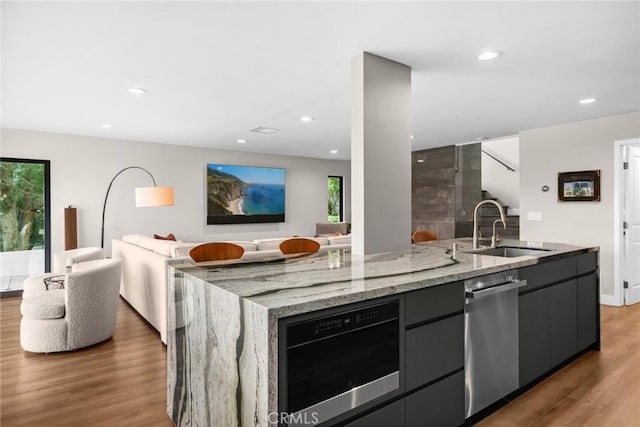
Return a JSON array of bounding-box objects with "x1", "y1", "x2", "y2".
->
[{"x1": 173, "y1": 238, "x2": 599, "y2": 318}]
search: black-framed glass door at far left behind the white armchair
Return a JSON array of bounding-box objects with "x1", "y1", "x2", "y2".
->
[{"x1": 0, "y1": 157, "x2": 51, "y2": 297}]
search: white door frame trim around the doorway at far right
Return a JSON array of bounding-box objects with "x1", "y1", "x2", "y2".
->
[{"x1": 612, "y1": 138, "x2": 640, "y2": 306}]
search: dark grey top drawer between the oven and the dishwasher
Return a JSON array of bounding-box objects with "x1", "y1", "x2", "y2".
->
[{"x1": 405, "y1": 282, "x2": 464, "y2": 326}]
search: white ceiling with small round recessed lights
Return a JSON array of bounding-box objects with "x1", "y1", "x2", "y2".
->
[{"x1": 1, "y1": 1, "x2": 640, "y2": 159}]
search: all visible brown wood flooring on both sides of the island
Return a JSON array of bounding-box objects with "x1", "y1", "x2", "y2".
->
[{"x1": 0, "y1": 298, "x2": 640, "y2": 427}]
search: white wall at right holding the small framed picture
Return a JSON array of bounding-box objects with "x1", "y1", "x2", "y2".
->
[{"x1": 520, "y1": 112, "x2": 640, "y2": 296}]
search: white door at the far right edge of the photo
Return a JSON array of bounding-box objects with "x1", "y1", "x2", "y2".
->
[{"x1": 623, "y1": 146, "x2": 640, "y2": 305}]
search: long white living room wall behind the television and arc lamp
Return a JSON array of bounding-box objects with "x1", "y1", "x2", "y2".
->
[{"x1": 0, "y1": 129, "x2": 351, "y2": 258}]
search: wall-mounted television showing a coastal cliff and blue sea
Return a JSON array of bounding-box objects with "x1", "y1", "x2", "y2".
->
[{"x1": 206, "y1": 163, "x2": 285, "y2": 225}]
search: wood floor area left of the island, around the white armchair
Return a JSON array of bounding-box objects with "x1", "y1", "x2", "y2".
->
[{"x1": 0, "y1": 298, "x2": 173, "y2": 427}]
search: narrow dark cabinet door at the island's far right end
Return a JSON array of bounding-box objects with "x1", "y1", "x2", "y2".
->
[{"x1": 578, "y1": 273, "x2": 600, "y2": 351}]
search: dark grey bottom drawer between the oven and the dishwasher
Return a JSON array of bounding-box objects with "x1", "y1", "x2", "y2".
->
[{"x1": 406, "y1": 371, "x2": 464, "y2": 427}]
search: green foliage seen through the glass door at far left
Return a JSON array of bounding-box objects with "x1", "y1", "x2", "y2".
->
[{"x1": 0, "y1": 161, "x2": 45, "y2": 252}]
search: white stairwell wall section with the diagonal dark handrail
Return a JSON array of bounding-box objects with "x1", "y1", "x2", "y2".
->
[{"x1": 482, "y1": 136, "x2": 520, "y2": 209}]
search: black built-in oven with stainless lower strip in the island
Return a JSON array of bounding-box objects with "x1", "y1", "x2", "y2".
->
[{"x1": 279, "y1": 299, "x2": 401, "y2": 426}]
